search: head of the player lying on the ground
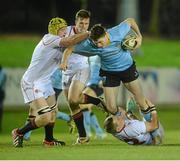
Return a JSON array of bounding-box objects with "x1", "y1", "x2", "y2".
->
[{"x1": 104, "y1": 115, "x2": 123, "y2": 134}]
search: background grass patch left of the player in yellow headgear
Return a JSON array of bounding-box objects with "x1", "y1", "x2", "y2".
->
[{"x1": 0, "y1": 35, "x2": 41, "y2": 67}]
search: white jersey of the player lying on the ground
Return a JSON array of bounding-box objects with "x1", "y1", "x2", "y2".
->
[{"x1": 113, "y1": 119, "x2": 152, "y2": 145}]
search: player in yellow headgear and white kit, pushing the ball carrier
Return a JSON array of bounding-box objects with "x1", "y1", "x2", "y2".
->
[{"x1": 12, "y1": 17, "x2": 88, "y2": 147}]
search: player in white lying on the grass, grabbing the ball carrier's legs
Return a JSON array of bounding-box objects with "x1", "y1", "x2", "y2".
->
[{"x1": 104, "y1": 99, "x2": 164, "y2": 145}]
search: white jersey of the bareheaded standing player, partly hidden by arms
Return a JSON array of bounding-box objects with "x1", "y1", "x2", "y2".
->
[{"x1": 63, "y1": 26, "x2": 89, "y2": 73}]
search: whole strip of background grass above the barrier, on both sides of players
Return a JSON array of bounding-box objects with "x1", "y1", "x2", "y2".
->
[{"x1": 0, "y1": 35, "x2": 180, "y2": 67}]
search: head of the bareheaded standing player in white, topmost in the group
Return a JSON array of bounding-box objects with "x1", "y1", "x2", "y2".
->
[{"x1": 75, "y1": 9, "x2": 91, "y2": 33}]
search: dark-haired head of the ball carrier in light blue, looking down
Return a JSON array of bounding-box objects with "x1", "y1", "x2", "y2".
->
[{"x1": 90, "y1": 24, "x2": 110, "y2": 48}]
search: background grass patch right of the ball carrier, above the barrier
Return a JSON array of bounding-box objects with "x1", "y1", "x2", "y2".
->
[{"x1": 135, "y1": 38, "x2": 180, "y2": 67}]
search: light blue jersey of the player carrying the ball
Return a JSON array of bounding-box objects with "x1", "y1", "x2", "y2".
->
[{"x1": 74, "y1": 22, "x2": 133, "y2": 71}]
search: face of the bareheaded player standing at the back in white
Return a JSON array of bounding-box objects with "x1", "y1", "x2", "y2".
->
[{"x1": 75, "y1": 18, "x2": 90, "y2": 33}]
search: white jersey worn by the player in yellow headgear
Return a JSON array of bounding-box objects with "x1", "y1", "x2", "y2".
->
[{"x1": 23, "y1": 34, "x2": 63, "y2": 83}]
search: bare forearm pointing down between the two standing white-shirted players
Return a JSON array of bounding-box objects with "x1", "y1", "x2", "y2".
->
[{"x1": 60, "y1": 46, "x2": 73, "y2": 70}]
